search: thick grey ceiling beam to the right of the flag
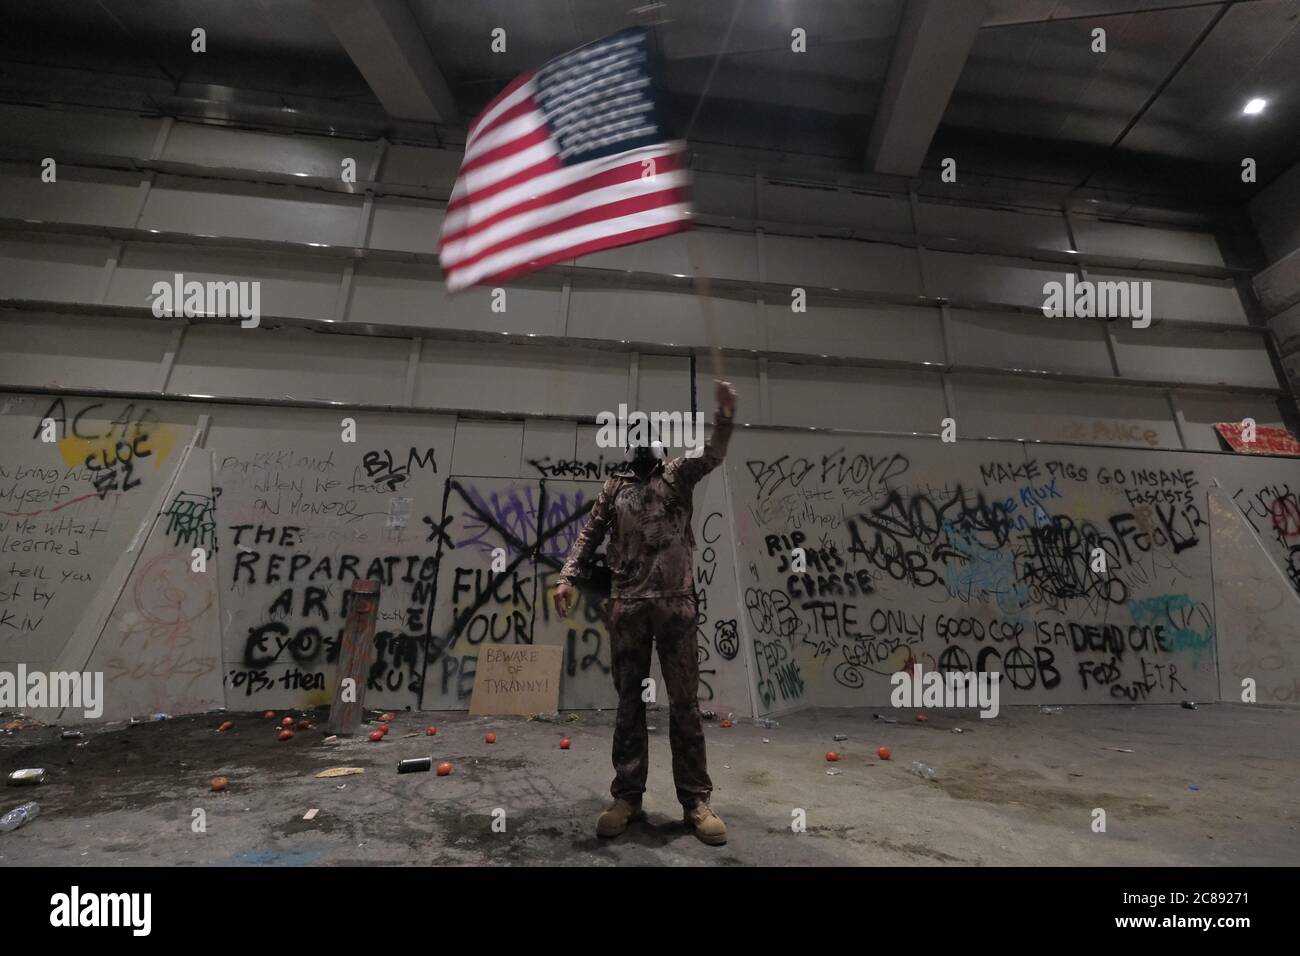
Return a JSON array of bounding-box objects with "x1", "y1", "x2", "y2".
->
[{"x1": 867, "y1": 0, "x2": 988, "y2": 176}]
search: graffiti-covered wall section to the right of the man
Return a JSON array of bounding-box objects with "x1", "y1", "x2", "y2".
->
[{"x1": 727, "y1": 431, "x2": 1300, "y2": 713}]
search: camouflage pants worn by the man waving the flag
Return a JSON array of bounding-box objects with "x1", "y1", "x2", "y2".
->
[{"x1": 608, "y1": 596, "x2": 714, "y2": 808}]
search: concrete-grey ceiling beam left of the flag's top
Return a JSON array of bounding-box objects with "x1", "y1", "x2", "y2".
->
[{"x1": 316, "y1": 0, "x2": 459, "y2": 124}]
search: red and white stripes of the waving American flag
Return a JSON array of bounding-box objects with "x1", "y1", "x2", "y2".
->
[{"x1": 438, "y1": 73, "x2": 690, "y2": 291}]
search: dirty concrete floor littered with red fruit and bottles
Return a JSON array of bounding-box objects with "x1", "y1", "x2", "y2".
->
[{"x1": 0, "y1": 705, "x2": 1300, "y2": 866}]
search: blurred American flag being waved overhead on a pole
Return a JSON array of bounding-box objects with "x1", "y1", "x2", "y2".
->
[{"x1": 439, "y1": 29, "x2": 690, "y2": 291}]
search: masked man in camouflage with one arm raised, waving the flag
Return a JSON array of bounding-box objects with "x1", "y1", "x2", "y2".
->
[{"x1": 555, "y1": 381, "x2": 736, "y2": 845}]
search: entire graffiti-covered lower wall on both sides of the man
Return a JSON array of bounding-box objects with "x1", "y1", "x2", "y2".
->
[{"x1": 0, "y1": 395, "x2": 1300, "y2": 719}]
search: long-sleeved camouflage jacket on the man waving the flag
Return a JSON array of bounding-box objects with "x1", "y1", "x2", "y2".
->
[{"x1": 560, "y1": 411, "x2": 732, "y2": 601}]
